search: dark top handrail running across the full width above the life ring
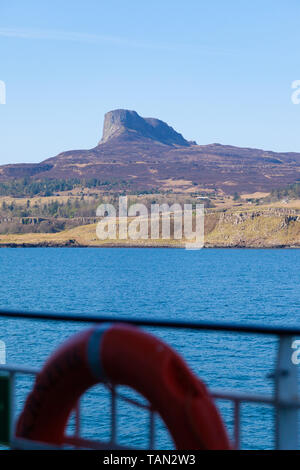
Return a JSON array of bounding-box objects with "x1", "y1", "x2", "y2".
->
[{"x1": 0, "y1": 310, "x2": 300, "y2": 336}]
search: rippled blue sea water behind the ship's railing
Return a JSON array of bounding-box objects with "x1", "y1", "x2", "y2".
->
[{"x1": 0, "y1": 248, "x2": 300, "y2": 449}]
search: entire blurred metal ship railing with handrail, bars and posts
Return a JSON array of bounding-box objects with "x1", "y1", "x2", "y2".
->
[{"x1": 0, "y1": 311, "x2": 300, "y2": 449}]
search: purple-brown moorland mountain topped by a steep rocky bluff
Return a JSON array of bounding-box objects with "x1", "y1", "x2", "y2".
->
[{"x1": 0, "y1": 109, "x2": 300, "y2": 194}]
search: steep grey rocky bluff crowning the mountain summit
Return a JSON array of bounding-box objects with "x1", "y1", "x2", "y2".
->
[{"x1": 99, "y1": 109, "x2": 190, "y2": 147}]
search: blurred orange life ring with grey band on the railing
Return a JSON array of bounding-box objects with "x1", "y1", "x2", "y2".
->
[{"x1": 16, "y1": 324, "x2": 230, "y2": 449}]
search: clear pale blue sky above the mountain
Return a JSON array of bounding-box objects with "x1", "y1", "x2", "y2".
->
[{"x1": 0, "y1": 0, "x2": 300, "y2": 164}]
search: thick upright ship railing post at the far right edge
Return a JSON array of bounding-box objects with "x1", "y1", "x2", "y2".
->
[{"x1": 274, "y1": 336, "x2": 298, "y2": 450}]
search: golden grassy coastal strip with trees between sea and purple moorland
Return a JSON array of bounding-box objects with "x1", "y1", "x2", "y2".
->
[{"x1": 0, "y1": 185, "x2": 300, "y2": 248}]
